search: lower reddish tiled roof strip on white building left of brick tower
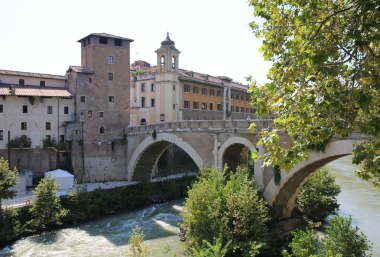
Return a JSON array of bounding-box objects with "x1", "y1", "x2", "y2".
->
[{"x1": 0, "y1": 86, "x2": 73, "y2": 97}]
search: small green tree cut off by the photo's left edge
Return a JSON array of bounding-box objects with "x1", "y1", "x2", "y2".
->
[{"x1": 0, "y1": 158, "x2": 18, "y2": 216}]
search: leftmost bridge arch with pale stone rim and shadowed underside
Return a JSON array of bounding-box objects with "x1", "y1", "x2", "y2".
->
[{"x1": 128, "y1": 133, "x2": 204, "y2": 181}]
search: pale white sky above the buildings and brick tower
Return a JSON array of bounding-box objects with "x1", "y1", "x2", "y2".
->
[{"x1": 0, "y1": 0, "x2": 270, "y2": 84}]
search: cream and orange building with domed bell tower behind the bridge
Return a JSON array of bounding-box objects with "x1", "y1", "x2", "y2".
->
[{"x1": 130, "y1": 34, "x2": 253, "y2": 126}]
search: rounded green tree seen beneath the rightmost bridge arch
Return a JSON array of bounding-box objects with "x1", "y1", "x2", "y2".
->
[{"x1": 296, "y1": 169, "x2": 341, "y2": 221}]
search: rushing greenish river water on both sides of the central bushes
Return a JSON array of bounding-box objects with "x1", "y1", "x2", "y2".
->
[{"x1": 0, "y1": 157, "x2": 380, "y2": 257}]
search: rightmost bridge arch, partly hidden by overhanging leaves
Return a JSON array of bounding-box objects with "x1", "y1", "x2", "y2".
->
[{"x1": 263, "y1": 139, "x2": 364, "y2": 218}]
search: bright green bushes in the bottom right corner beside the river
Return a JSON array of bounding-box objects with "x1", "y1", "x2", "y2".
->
[{"x1": 283, "y1": 214, "x2": 371, "y2": 257}]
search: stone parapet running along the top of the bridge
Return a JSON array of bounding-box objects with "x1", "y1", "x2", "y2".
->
[{"x1": 125, "y1": 119, "x2": 273, "y2": 135}]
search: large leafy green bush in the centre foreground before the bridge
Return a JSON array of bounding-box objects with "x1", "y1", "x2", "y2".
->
[{"x1": 182, "y1": 168, "x2": 269, "y2": 256}]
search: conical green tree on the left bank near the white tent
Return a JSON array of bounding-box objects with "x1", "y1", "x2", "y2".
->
[{"x1": 27, "y1": 176, "x2": 69, "y2": 230}]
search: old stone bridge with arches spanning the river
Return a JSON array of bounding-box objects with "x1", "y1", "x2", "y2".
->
[{"x1": 125, "y1": 119, "x2": 368, "y2": 218}]
